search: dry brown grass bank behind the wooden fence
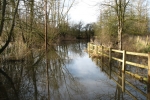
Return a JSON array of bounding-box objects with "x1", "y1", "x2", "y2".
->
[{"x1": 94, "y1": 34, "x2": 150, "y2": 53}]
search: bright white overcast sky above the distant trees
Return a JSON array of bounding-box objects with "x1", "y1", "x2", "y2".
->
[{"x1": 69, "y1": 0, "x2": 100, "y2": 24}]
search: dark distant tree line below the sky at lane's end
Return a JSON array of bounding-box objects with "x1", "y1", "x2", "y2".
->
[{"x1": 60, "y1": 21, "x2": 95, "y2": 40}]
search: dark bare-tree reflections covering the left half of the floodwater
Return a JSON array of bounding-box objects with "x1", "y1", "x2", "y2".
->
[{"x1": 0, "y1": 41, "x2": 87, "y2": 100}]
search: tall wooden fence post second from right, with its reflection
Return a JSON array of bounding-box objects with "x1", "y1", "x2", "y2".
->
[{"x1": 122, "y1": 50, "x2": 126, "y2": 92}]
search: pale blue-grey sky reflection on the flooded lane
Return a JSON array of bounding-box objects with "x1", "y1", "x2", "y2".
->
[{"x1": 67, "y1": 52, "x2": 116, "y2": 100}]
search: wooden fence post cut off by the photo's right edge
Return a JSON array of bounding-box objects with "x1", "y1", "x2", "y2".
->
[{"x1": 147, "y1": 53, "x2": 150, "y2": 100}]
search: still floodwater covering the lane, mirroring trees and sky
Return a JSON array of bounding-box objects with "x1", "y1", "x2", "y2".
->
[{"x1": 0, "y1": 42, "x2": 146, "y2": 100}]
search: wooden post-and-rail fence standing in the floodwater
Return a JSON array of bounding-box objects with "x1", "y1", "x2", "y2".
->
[{"x1": 87, "y1": 43, "x2": 150, "y2": 100}]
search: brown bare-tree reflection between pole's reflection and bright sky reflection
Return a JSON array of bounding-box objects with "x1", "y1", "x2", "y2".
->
[{"x1": 48, "y1": 44, "x2": 86, "y2": 100}]
